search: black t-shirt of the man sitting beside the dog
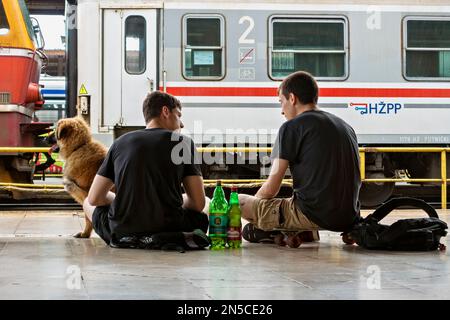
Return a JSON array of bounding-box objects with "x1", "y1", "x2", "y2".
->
[{"x1": 98, "y1": 128, "x2": 201, "y2": 237}]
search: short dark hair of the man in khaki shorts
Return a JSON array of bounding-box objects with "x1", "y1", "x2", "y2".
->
[{"x1": 278, "y1": 71, "x2": 319, "y2": 104}]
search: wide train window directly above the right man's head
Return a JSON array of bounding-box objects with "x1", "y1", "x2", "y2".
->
[{"x1": 269, "y1": 17, "x2": 348, "y2": 80}]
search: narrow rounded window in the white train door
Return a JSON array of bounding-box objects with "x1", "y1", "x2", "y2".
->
[{"x1": 125, "y1": 16, "x2": 147, "y2": 74}]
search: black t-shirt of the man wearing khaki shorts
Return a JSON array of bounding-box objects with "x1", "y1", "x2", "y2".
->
[{"x1": 273, "y1": 110, "x2": 361, "y2": 231}]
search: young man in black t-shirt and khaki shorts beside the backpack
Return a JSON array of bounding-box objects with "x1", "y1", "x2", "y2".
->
[{"x1": 240, "y1": 71, "x2": 361, "y2": 240}]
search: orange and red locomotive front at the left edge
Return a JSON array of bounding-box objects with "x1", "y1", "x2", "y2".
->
[{"x1": 0, "y1": 0, "x2": 51, "y2": 182}]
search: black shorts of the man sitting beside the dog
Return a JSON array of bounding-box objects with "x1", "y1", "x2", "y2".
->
[{"x1": 92, "y1": 206, "x2": 209, "y2": 245}]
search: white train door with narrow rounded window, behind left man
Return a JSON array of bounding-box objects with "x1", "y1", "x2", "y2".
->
[{"x1": 102, "y1": 9, "x2": 158, "y2": 126}]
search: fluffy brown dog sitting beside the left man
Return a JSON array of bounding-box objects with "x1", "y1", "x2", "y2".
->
[{"x1": 55, "y1": 117, "x2": 107, "y2": 238}]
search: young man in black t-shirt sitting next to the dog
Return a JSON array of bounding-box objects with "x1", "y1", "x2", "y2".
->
[{"x1": 83, "y1": 91, "x2": 208, "y2": 246}]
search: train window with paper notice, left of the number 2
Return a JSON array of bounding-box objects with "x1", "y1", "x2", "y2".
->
[{"x1": 183, "y1": 14, "x2": 225, "y2": 80}]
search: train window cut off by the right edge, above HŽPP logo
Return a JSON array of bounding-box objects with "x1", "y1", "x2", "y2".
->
[{"x1": 403, "y1": 17, "x2": 450, "y2": 80}]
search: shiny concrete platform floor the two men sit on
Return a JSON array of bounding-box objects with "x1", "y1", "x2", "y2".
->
[{"x1": 0, "y1": 210, "x2": 450, "y2": 300}]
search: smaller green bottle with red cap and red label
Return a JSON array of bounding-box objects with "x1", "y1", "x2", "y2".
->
[{"x1": 227, "y1": 186, "x2": 242, "y2": 248}]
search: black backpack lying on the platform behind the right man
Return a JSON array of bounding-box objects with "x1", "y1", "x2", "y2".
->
[{"x1": 342, "y1": 198, "x2": 447, "y2": 251}]
